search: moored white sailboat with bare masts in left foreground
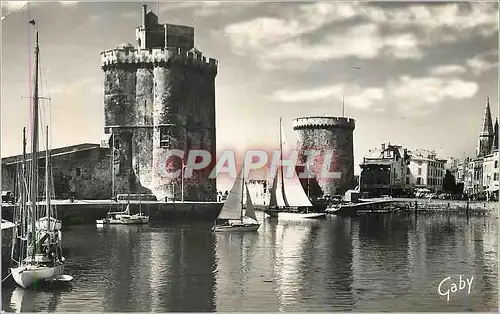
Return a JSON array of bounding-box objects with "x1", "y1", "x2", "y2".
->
[{"x1": 10, "y1": 20, "x2": 73, "y2": 288}]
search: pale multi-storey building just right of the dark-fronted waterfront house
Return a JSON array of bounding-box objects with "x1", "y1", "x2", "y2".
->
[{"x1": 405, "y1": 149, "x2": 446, "y2": 192}]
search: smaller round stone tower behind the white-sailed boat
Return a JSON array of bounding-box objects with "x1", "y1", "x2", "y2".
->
[{"x1": 293, "y1": 117, "x2": 355, "y2": 196}]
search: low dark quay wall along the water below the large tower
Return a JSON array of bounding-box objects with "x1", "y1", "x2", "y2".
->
[{"x1": 2, "y1": 200, "x2": 223, "y2": 225}]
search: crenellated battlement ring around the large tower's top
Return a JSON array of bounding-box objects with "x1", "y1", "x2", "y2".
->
[{"x1": 101, "y1": 45, "x2": 218, "y2": 71}]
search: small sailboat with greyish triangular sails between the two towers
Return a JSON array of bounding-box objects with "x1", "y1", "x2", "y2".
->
[{"x1": 212, "y1": 167, "x2": 260, "y2": 232}]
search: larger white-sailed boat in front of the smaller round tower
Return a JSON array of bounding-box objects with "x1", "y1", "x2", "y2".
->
[{"x1": 264, "y1": 118, "x2": 326, "y2": 220}]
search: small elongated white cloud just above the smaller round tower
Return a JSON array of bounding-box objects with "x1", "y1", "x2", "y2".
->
[{"x1": 273, "y1": 84, "x2": 385, "y2": 110}]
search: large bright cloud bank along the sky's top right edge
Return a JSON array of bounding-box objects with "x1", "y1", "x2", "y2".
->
[{"x1": 224, "y1": 2, "x2": 498, "y2": 68}]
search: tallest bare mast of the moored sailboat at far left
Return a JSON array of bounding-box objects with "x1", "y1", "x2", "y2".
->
[{"x1": 30, "y1": 20, "x2": 40, "y2": 260}]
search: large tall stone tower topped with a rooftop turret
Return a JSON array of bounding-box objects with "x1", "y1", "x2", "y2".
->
[{"x1": 101, "y1": 5, "x2": 217, "y2": 201}]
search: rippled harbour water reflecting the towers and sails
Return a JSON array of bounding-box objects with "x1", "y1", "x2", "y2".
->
[{"x1": 2, "y1": 214, "x2": 498, "y2": 312}]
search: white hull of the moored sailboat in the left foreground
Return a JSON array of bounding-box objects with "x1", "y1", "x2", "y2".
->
[{"x1": 10, "y1": 265, "x2": 64, "y2": 289}]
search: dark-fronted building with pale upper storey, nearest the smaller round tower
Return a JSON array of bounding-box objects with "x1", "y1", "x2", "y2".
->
[{"x1": 360, "y1": 143, "x2": 410, "y2": 196}]
